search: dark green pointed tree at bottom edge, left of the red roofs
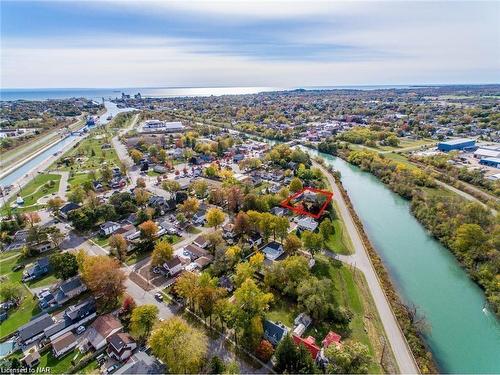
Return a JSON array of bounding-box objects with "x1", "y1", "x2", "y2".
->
[{"x1": 274, "y1": 335, "x2": 316, "y2": 374}]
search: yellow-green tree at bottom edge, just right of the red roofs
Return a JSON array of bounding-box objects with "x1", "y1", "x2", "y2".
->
[{"x1": 325, "y1": 341, "x2": 371, "y2": 374}]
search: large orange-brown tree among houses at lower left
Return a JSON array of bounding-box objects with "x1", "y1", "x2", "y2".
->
[{"x1": 81, "y1": 255, "x2": 127, "y2": 307}]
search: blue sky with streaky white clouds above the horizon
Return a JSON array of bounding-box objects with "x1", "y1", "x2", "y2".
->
[{"x1": 0, "y1": 0, "x2": 500, "y2": 88}]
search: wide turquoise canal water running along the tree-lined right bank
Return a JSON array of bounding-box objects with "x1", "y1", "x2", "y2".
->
[{"x1": 304, "y1": 148, "x2": 500, "y2": 374}]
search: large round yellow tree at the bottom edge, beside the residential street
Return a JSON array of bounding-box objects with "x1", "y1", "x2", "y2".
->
[{"x1": 149, "y1": 316, "x2": 207, "y2": 374}]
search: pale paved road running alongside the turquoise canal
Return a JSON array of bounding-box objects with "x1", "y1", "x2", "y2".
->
[{"x1": 313, "y1": 162, "x2": 419, "y2": 374}]
